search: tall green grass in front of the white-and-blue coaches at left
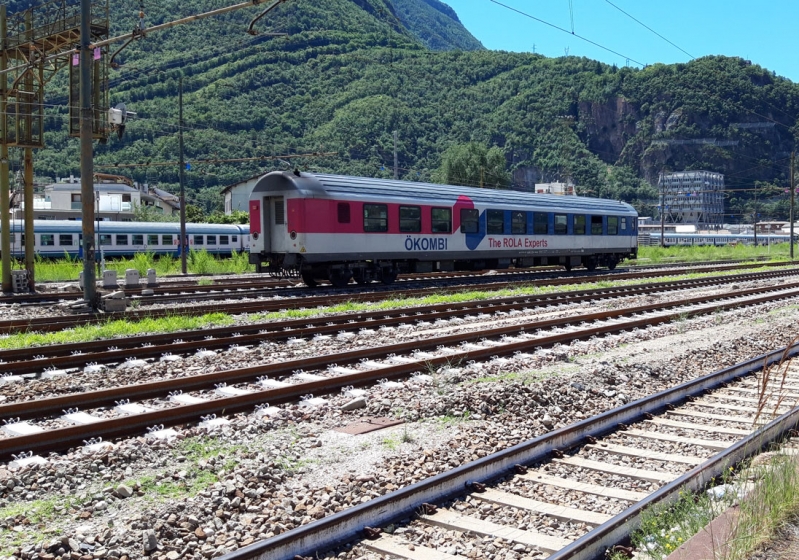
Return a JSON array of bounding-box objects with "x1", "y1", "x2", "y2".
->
[{"x1": 30, "y1": 249, "x2": 255, "y2": 282}]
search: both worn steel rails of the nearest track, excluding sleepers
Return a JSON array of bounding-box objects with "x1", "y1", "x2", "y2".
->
[{"x1": 220, "y1": 345, "x2": 799, "y2": 560}]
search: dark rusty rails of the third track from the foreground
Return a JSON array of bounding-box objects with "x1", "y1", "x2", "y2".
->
[{"x1": 0, "y1": 270, "x2": 799, "y2": 375}]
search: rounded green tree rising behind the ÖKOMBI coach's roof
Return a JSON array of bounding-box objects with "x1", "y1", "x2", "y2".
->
[{"x1": 434, "y1": 142, "x2": 511, "y2": 189}]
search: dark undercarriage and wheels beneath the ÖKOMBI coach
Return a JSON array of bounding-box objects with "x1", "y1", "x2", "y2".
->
[{"x1": 256, "y1": 253, "x2": 634, "y2": 288}]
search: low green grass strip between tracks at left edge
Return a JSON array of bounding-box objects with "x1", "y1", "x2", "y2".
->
[{"x1": 0, "y1": 313, "x2": 233, "y2": 350}]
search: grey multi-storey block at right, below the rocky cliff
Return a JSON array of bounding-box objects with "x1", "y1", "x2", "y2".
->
[{"x1": 658, "y1": 171, "x2": 724, "y2": 229}]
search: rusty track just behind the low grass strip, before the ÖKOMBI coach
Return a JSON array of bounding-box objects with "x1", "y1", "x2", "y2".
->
[{"x1": 0, "y1": 264, "x2": 792, "y2": 334}]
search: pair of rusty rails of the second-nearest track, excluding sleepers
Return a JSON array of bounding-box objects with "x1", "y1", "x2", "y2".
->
[{"x1": 0, "y1": 284, "x2": 799, "y2": 457}]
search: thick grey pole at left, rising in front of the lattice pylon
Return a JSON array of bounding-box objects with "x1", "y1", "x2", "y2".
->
[{"x1": 79, "y1": 0, "x2": 97, "y2": 310}]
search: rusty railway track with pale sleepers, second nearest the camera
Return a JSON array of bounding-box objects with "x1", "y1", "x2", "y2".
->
[{"x1": 0, "y1": 274, "x2": 799, "y2": 457}]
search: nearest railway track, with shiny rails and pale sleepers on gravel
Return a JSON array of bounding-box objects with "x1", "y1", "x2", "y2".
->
[{"x1": 223, "y1": 346, "x2": 799, "y2": 560}]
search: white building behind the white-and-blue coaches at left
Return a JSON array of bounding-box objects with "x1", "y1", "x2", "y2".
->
[{"x1": 12, "y1": 174, "x2": 180, "y2": 222}]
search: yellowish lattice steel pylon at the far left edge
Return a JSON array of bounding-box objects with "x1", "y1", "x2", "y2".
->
[{"x1": 0, "y1": 0, "x2": 109, "y2": 291}]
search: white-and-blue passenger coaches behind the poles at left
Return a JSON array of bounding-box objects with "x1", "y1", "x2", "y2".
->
[{"x1": 0, "y1": 220, "x2": 250, "y2": 258}]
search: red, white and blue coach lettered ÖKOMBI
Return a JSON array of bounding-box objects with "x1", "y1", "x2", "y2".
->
[{"x1": 250, "y1": 171, "x2": 638, "y2": 286}]
